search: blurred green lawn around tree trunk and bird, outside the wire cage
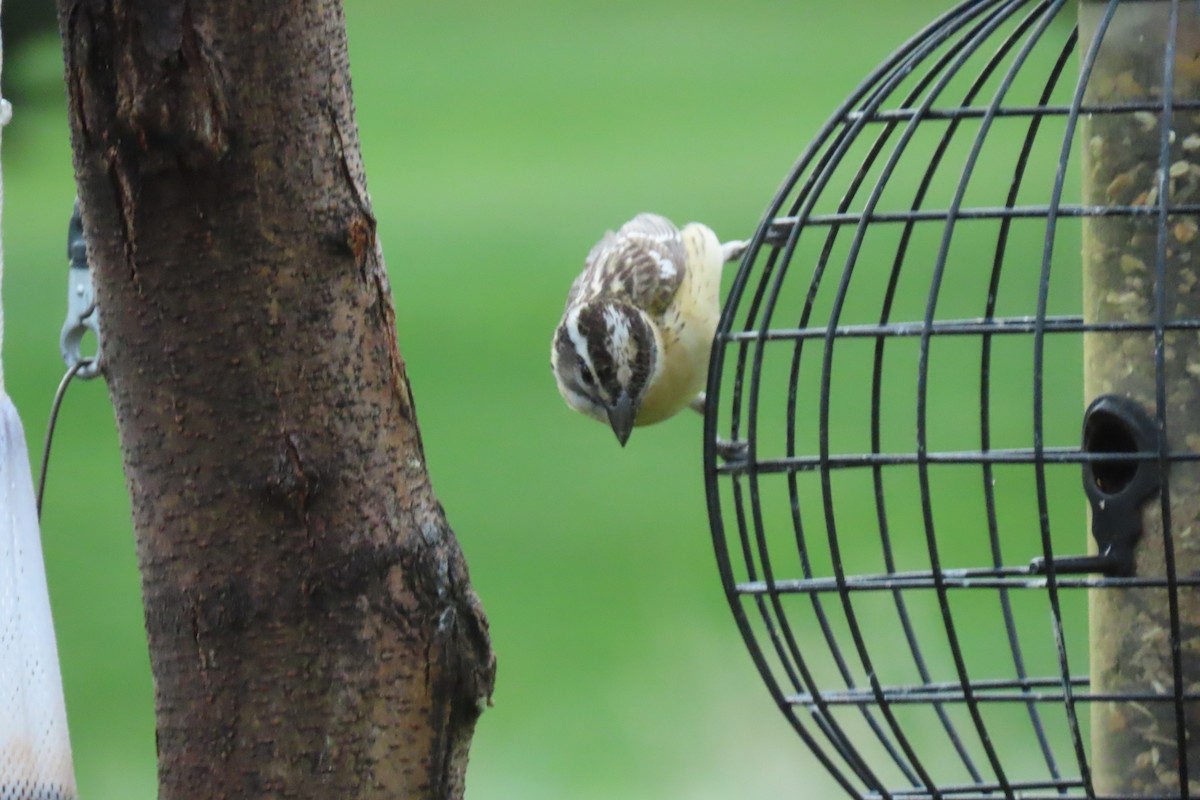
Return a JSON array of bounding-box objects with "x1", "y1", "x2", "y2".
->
[{"x1": 4, "y1": 0, "x2": 1032, "y2": 800}]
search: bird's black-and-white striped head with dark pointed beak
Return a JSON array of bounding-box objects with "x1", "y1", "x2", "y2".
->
[{"x1": 550, "y1": 300, "x2": 660, "y2": 446}]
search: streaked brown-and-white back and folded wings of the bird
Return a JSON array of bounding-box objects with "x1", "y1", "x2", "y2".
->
[{"x1": 566, "y1": 213, "x2": 688, "y2": 315}]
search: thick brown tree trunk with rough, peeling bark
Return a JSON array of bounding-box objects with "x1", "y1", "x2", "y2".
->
[{"x1": 58, "y1": 0, "x2": 494, "y2": 800}]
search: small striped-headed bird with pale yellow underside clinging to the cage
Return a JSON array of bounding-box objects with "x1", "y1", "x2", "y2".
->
[{"x1": 550, "y1": 213, "x2": 745, "y2": 447}]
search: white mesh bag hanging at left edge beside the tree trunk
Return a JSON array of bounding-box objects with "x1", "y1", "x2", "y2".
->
[{"x1": 0, "y1": 3, "x2": 76, "y2": 800}]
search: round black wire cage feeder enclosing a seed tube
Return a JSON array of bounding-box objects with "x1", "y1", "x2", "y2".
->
[{"x1": 706, "y1": 0, "x2": 1200, "y2": 800}]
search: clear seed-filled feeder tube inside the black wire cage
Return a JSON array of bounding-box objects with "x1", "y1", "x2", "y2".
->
[{"x1": 1079, "y1": 0, "x2": 1200, "y2": 796}]
